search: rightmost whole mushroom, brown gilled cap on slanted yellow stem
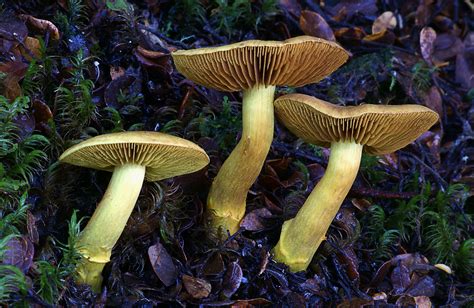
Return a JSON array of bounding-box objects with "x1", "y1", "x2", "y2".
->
[{"x1": 273, "y1": 94, "x2": 438, "y2": 272}]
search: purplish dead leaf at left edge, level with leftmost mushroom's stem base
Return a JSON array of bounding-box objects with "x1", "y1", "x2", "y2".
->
[{"x1": 2, "y1": 236, "x2": 35, "y2": 273}]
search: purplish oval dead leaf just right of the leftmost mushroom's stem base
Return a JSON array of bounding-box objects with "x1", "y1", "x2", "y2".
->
[{"x1": 148, "y1": 242, "x2": 178, "y2": 287}]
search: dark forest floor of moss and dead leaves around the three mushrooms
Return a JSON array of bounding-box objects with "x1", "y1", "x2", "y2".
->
[{"x1": 0, "y1": 0, "x2": 474, "y2": 307}]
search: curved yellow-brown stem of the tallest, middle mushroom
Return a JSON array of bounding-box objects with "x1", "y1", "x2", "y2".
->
[{"x1": 207, "y1": 86, "x2": 275, "y2": 237}]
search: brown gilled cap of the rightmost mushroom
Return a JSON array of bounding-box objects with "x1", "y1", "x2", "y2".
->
[{"x1": 275, "y1": 94, "x2": 438, "y2": 155}]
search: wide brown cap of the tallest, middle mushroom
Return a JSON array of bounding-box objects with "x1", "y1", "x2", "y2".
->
[{"x1": 172, "y1": 36, "x2": 348, "y2": 91}]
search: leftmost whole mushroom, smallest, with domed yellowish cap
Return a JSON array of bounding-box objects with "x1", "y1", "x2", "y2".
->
[{"x1": 59, "y1": 132, "x2": 209, "y2": 291}]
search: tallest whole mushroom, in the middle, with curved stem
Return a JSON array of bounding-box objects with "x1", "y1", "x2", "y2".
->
[{"x1": 172, "y1": 36, "x2": 348, "y2": 234}]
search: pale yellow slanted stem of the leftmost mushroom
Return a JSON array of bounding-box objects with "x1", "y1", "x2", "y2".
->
[{"x1": 76, "y1": 164, "x2": 145, "y2": 292}]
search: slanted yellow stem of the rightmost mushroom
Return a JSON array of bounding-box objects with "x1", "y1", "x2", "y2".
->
[{"x1": 273, "y1": 142, "x2": 363, "y2": 272}]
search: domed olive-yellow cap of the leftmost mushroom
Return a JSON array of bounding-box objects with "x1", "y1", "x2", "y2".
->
[{"x1": 59, "y1": 131, "x2": 209, "y2": 181}]
